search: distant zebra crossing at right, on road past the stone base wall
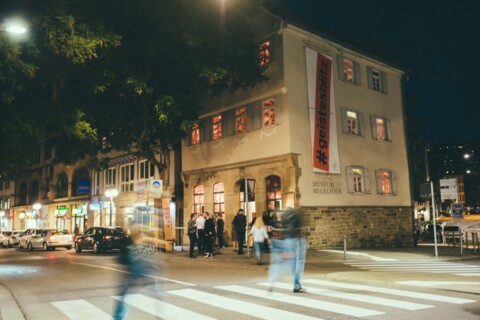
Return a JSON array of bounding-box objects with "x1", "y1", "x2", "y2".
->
[{"x1": 345, "y1": 260, "x2": 480, "y2": 276}]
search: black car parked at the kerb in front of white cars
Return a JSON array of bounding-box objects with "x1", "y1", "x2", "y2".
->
[{"x1": 75, "y1": 227, "x2": 128, "y2": 253}]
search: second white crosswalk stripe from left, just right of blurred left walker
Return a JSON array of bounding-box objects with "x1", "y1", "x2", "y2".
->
[{"x1": 113, "y1": 294, "x2": 213, "y2": 320}]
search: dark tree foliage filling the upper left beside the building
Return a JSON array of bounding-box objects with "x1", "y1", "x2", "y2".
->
[{"x1": 0, "y1": 0, "x2": 266, "y2": 182}]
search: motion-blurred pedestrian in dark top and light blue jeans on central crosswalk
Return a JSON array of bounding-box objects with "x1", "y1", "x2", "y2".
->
[{"x1": 268, "y1": 207, "x2": 306, "y2": 293}]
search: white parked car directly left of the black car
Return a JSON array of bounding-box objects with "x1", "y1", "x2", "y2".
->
[{"x1": 27, "y1": 229, "x2": 74, "y2": 251}]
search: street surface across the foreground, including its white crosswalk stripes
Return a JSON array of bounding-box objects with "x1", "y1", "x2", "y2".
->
[{"x1": 0, "y1": 248, "x2": 480, "y2": 320}]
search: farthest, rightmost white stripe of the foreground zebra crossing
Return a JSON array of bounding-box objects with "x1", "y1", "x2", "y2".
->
[{"x1": 302, "y1": 279, "x2": 477, "y2": 304}]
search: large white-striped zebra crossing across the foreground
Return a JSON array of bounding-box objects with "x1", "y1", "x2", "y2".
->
[{"x1": 51, "y1": 279, "x2": 478, "y2": 320}]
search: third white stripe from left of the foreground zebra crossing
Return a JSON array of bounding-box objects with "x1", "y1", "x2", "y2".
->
[{"x1": 167, "y1": 289, "x2": 320, "y2": 320}]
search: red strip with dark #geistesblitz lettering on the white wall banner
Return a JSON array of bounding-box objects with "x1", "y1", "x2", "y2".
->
[{"x1": 313, "y1": 53, "x2": 332, "y2": 172}]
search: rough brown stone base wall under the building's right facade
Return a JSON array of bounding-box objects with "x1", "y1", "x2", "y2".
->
[{"x1": 302, "y1": 207, "x2": 414, "y2": 249}]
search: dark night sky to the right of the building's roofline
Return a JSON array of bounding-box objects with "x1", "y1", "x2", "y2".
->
[{"x1": 274, "y1": 0, "x2": 480, "y2": 144}]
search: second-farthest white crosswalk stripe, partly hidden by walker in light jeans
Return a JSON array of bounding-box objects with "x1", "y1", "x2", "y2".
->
[{"x1": 258, "y1": 283, "x2": 434, "y2": 310}]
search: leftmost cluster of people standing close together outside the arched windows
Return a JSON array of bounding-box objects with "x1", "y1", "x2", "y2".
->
[{"x1": 188, "y1": 212, "x2": 225, "y2": 258}]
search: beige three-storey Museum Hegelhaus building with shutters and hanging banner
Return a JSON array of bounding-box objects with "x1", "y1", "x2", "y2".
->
[{"x1": 182, "y1": 8, "x2": 413, "y2": 248}]
